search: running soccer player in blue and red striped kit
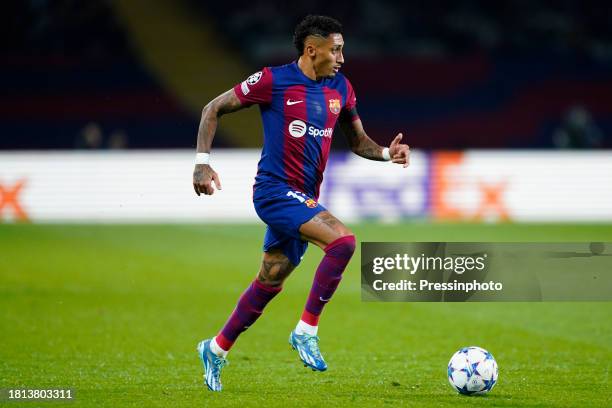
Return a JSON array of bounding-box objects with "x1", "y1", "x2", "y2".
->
[{"x1": 193, "y1": 16, "x2": 410, "y2": 391}]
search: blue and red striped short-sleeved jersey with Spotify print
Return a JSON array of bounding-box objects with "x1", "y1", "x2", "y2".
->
[{"x1": 234, "y1": 62, "x2": 358, "y2": 199}]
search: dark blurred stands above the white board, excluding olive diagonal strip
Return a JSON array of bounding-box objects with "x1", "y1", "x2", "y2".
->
[{"x1": 0, "y1": 0, "x2": 612, "y2": 149}]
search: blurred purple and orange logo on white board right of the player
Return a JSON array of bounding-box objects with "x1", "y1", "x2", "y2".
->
[{"x1": 323, "y1": 151, "x2": 512, "y2": 221}]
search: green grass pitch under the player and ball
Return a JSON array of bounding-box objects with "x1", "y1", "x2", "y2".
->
[{"x1": 0, "y1": 223, "x2": 612, "y2": 407}]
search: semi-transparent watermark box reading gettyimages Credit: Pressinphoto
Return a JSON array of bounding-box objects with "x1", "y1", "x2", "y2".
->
[{"x1": 361, "y1": 242, "x2": 612, "y2": 302}]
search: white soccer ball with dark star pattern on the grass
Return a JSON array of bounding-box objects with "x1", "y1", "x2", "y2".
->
[{"x1": 448, "y1": 347, "x2": 497, "y2": 395}]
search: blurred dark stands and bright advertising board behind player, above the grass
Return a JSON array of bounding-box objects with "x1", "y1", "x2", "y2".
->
[{"x1": 0, "y1": 0, "x2": 612, "y2": 222}]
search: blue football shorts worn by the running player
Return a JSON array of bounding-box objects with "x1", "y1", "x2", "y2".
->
[{"x1": 253, "y1": 183, "x2": 327, "y2": 266}]
